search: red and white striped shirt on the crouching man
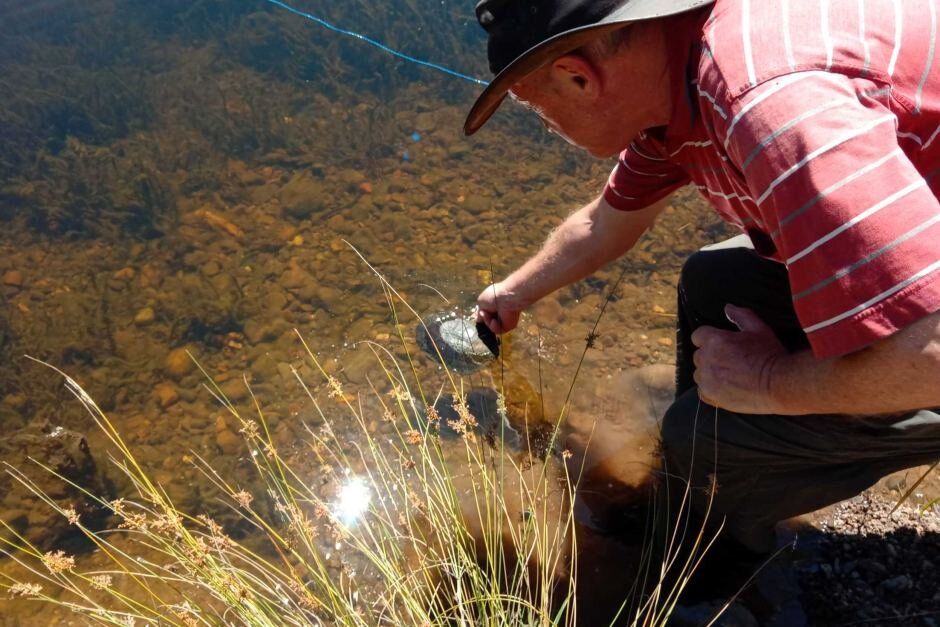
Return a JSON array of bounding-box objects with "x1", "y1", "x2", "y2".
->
[{"x1": 604, "y1": 0, "x2": 940, "y2": 358}]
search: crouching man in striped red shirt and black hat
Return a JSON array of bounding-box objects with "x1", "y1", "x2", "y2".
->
[{"x1": 465, "y1": 0, "x2": 940, "y2": 551}]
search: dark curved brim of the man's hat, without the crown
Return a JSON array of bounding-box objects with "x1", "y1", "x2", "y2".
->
[{"x1": 463, "y1": 0, "x2": 715, "y2": 135}]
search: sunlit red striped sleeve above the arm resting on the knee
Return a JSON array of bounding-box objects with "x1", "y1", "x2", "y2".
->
[{"x1": 716, "y1": 72, "x2": 940, "y2": 358}]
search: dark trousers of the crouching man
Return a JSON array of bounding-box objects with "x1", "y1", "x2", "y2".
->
[{"x1": 662, "y1": 248, "x2": 940, "y2": 551}]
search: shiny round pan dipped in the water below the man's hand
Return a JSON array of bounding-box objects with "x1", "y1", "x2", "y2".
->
[{"x1": 415, "y1": 313, "x2": 499, "y2": 373}]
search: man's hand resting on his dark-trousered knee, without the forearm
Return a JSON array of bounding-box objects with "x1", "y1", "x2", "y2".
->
[{"x1": 692, "y1": 305, "x2": 788, "y2": 414}]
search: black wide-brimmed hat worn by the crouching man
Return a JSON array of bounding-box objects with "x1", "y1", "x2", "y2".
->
[{"x1": 463, "y1": 0, "x2": 714, "y2": 135}]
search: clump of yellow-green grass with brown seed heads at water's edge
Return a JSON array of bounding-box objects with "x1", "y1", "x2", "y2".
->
[{"x1": 0, "y1": 266, "x2": 703, "y2": 627}]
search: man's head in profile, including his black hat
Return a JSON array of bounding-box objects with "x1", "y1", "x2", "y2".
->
[{"x1": 464, "y1": 0, "x2": 713, "y2": 156}]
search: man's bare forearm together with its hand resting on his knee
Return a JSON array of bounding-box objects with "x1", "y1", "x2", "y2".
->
[{"x1": 692, "y1": 306, "x2": 940, "y2": 415}]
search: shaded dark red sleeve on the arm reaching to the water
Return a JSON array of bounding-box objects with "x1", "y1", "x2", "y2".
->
[{"x1": 604, "y1": 133, "x2": 689, "y2": 211}]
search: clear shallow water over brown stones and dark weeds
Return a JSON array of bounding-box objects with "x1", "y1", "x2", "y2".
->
[{"x1": 0, "y1": 0, "x2": 736, "y2": 625}]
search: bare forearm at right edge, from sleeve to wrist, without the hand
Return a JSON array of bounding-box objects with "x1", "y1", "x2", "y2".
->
[{"x1": 770, "y1": 314, "x2": 940, "y2": 415}]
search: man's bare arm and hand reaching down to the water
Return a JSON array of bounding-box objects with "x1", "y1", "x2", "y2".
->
[{"x1": 477, "y1": 197, "x2": 666, "y2": 333}]
